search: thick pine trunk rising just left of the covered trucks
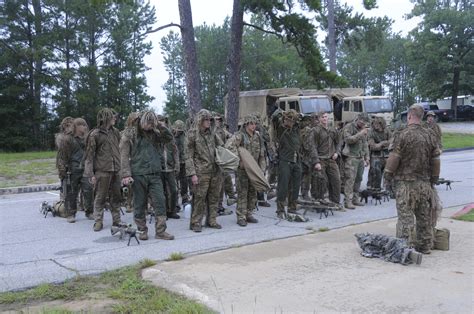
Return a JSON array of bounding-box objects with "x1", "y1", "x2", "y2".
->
[{"x1": 226, "y1": 0, "x2": 244, "y2": 132}]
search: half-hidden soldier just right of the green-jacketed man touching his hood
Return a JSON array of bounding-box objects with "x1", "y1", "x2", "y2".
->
[{"x1": 157, "y1": 115, "x2": 180, "y2": 219}]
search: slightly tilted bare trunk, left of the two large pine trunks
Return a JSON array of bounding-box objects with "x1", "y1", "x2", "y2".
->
[{"x1": 178, "y1": 0, "x2": 202, "y2": 116}]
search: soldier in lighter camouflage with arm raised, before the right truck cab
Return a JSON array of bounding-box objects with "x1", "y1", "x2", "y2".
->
[{"x1": 342, "y1": 113, "x2": 369, "y2": 209}]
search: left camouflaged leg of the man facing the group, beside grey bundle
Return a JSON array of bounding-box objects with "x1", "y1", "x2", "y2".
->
[{"x1": 396, "y1": 181, "x2": 415, "y2": 246}]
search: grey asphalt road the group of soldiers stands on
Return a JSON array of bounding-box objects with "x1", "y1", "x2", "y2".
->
[{"x1": 0, "y1": 150, "x2": 474, "y2": 291}]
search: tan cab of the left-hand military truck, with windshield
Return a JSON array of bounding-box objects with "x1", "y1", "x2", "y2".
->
[{"x1": 277, "y1": 95, "x2": 334, "y2": 125}]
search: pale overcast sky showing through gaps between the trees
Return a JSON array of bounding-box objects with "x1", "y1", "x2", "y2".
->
[{"x1": 145, "y1": 0, "x2": 418, "y2": 113}]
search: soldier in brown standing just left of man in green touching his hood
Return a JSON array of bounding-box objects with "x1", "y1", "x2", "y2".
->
[{"x1": 84, "y1": 108, "x2": 122, "y2": 231}]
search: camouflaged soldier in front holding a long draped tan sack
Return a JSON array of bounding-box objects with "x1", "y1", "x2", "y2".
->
[{"x1": 226, "y1": 115, "x2": 265, "y2": 227}]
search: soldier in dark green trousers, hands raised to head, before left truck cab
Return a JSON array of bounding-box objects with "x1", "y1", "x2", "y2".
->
[{"x1": 272, "y1": 109, "x2": 301, "y2": 219}]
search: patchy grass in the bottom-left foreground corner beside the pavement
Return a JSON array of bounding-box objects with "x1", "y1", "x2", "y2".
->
[{"x1": 0, "y1": 260, "x2": 212, "y2": 313}]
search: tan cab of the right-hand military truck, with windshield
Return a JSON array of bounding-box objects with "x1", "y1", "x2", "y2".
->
[{"x1": 341, "y1": 96, "x2": 393, "y2": 125}]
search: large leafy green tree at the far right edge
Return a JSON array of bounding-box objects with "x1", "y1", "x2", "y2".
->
[{"x1": 410, "y1": 0, "x2": 474, "y2": 117}]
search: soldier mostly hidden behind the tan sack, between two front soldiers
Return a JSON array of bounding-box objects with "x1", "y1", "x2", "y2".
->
[{"x1": 213, "y1": 112, "x2": 237, "y2": 215}]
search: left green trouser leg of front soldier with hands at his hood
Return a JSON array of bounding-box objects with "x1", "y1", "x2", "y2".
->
[{"x1": 131, "y1": 175, "x2": 148, "y2": 240}]
